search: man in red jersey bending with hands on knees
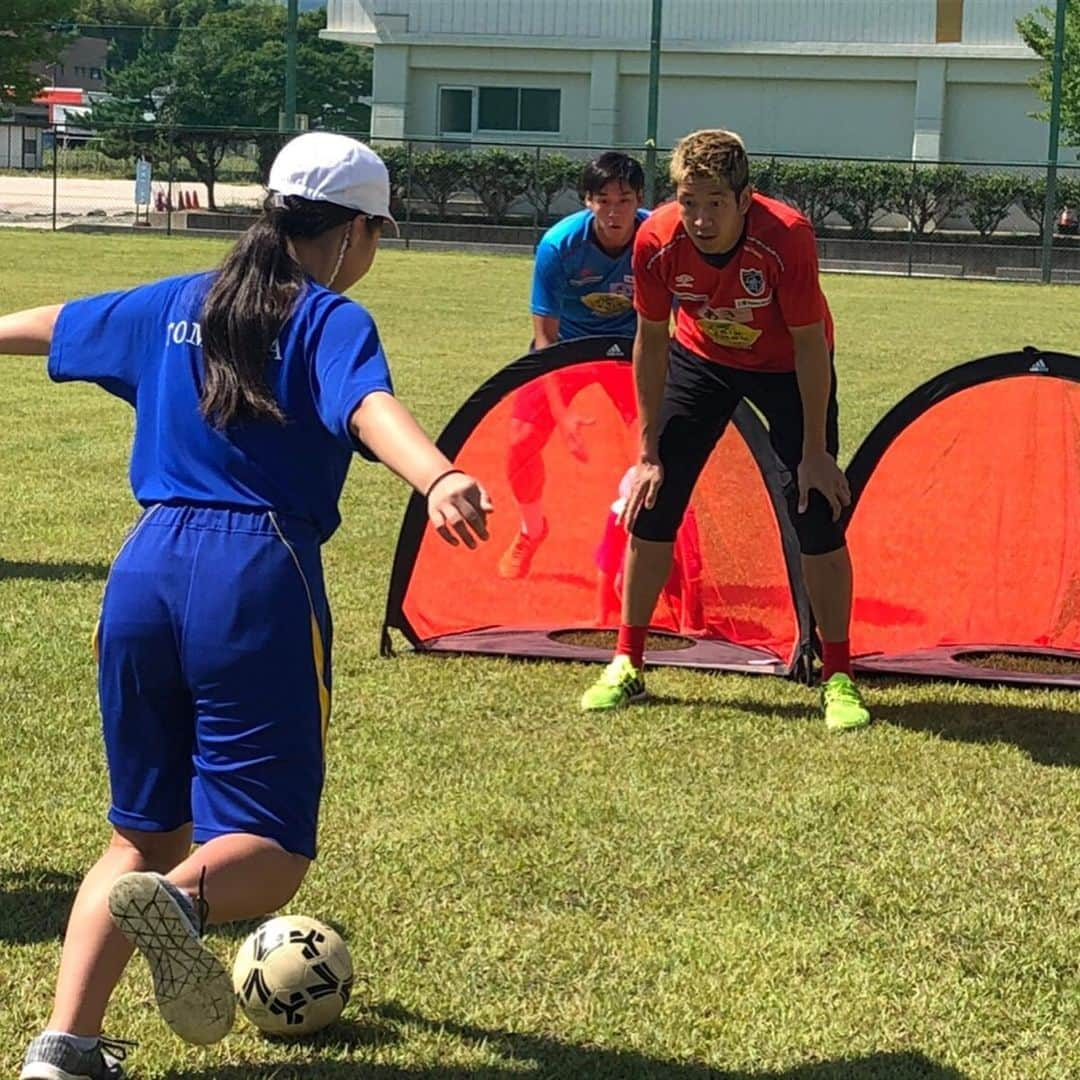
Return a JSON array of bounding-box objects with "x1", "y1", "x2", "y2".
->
[{"x1": 581, "y1": 131, "x2": 869, "y2": 730}]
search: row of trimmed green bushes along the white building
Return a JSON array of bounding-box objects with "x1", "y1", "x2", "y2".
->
[{"x1": 379, "y1": 145, "x2": 1080, "y2": 238}]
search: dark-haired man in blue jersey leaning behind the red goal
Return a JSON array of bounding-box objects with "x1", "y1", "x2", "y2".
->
[{"x1": 499, "y1": 150, "x2": 648, "y2": 578}]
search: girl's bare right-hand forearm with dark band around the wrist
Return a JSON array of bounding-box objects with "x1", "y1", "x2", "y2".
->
[{"x1": 349, "y1": 390, "x2": 492, "y2": 548}]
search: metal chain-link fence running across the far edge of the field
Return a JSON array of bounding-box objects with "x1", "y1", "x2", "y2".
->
[{"x1": 6, "y1": 127, "x2": 1080, "y2": 282}]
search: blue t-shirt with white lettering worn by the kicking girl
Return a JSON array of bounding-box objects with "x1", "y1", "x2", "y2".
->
[{"x1": 49, "y1": 273, "x2": 393, "y2": 540}]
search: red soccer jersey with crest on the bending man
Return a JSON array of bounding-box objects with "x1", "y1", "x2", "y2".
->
[{"x1": 633, "y1": 193, "x2": 833, "y2": 372}]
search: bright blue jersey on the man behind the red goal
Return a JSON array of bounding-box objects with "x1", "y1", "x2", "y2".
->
[{"x1": 532, "y1": 210, "x2": 649, "y2": 341}]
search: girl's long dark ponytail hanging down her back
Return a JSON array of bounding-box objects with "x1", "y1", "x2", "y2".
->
[{"x1": 199, "y1": 193, "x2": 359, "y2": 428}]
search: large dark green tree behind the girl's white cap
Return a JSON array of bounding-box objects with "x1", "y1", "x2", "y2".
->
[{"x1": 94, "y1": 0, "x2": 370, "y2": 207}]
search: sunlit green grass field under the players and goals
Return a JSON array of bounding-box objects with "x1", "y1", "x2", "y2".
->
[{"x1": 0, "y1": 230, "x2": 1080, "y2": 1080}]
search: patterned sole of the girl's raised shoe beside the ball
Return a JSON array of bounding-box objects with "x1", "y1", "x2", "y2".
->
[{"x1": 109, "y1": 874, "x2": 237, "y2": 1047}]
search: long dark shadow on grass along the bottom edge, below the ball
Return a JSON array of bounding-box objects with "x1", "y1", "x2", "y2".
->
[{"x1": 166, "y1": 1004, "x2": 964, "y2": 1080}]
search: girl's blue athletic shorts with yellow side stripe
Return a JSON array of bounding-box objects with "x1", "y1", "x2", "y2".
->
[{"x1": 98, "y1": 507, "x2": 332, "y2": 859}]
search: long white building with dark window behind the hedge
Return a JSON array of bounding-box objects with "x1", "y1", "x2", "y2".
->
[{"x1": 324, "y1": 0, "x2": 1048, "y2": 162}]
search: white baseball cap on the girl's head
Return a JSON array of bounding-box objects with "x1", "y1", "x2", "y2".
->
[{"x1": 267, "y1": 132, "x2": 397, "y2": 232}]
